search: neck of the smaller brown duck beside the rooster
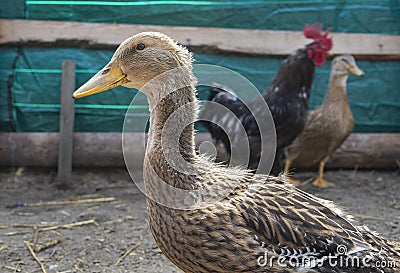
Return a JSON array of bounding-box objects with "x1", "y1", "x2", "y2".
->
[{"x1": 325, "y1": 72, "x2": 349, "y2": 105}]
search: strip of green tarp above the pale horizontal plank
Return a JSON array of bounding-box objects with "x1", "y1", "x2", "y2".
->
[{"x1": 22, "y1": 0, "x2": 400, "y2": 34}]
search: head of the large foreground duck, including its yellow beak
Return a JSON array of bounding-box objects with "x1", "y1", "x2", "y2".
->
[{"x1": 73, "y1": 32, "x2": 192, "y2": 98}]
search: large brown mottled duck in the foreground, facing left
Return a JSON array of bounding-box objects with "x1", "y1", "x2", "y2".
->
[{"x1": 74, "y1": 32, "x2": 400, "y2": 273}]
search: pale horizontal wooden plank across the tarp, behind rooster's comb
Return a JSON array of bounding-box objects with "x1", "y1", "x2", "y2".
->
[{"x1": 0, "y1": 19, "x2": 400, "y2": 59}]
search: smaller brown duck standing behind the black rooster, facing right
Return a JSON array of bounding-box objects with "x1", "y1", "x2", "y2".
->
[{"x1": 284, "y1": 55, "x2": 364, "y2": 187}]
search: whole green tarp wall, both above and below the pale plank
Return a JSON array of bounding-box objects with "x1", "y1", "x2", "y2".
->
[{"x1": 0, "y1": 0, "x2": 400, "y2": 132}]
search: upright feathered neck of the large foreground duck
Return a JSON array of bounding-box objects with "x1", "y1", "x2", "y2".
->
[{"x1": 145, "y1": 71, "x2": 198, "y2": 190}]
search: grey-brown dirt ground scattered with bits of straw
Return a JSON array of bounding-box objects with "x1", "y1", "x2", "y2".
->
[{"x1": 0, "y1": 168, "x2": 400, "y2": 273}]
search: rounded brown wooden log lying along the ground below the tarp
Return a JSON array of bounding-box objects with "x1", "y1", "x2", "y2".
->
[{"x1": 0, "y1": 133, "x2": 400, "y2": 169}]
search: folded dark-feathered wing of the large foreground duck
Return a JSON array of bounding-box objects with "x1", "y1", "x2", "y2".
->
[{"x1": 230, "y1": 176, "x2": 371, "y2": 257}]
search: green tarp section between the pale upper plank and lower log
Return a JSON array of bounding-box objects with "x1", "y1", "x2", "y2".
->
[{"x1": 1, "y1": 48, "x2": 400, "y2": 132}]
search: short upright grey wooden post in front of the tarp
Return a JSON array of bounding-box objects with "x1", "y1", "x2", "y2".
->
[{"x1": 58, "y1": 60, "x2": 75, "y2": 187}]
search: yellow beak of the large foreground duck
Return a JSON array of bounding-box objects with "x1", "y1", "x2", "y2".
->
[{"x1": 72, "y1": 59, "x2": 128, "y2": 99}]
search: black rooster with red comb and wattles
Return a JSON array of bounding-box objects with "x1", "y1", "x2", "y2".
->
[{"x1": 202, "y1": 24, "x2": 332, "y2": 175}]
